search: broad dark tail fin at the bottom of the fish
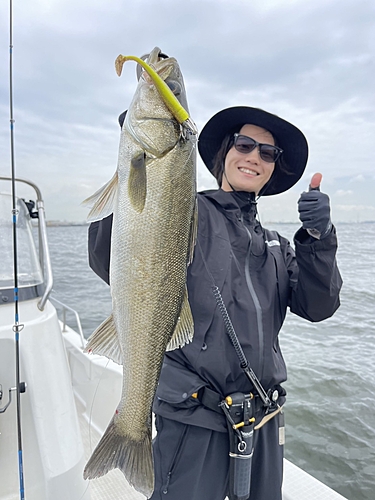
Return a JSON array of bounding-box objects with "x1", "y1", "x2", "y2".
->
[{"x1": 83, "y1": 415, "x2": 154, "y2": 498}]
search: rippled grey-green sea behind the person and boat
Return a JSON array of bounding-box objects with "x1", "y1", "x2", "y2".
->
[{"x1": 47, "y1": 222, "x2": 375, "y2": 500}]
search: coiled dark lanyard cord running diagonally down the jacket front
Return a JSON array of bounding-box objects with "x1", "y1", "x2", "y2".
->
[{"x1": 197, "y1": 238, "x2": 273, "y2": 408}]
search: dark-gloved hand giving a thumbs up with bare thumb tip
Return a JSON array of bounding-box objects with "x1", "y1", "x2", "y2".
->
[{"x1": 298, "y1": 174, "x2": 332, "y2": 240}]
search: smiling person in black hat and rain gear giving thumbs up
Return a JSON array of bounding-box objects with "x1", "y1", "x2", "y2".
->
[{"x1": 89, "y1": 106, "x2": 342, "y2": 500}]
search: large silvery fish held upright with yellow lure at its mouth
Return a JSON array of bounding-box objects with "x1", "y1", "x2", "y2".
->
[{"x1": 84, "y1": 47, "x2": 197, "y2": 497}]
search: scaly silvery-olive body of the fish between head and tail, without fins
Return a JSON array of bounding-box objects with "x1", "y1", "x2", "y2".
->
[{"x1": 111, "y1": 136, "x2": 194, "y2": 437}]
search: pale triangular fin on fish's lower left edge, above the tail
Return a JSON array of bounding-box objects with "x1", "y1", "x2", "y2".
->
[{"x1": 85, "y1": 314, "x2": 122, "y2": 365}]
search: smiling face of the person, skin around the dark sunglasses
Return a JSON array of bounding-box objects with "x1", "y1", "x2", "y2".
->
[{"x1": 221, "y1": 124, "x2": 275, "y2": 194}]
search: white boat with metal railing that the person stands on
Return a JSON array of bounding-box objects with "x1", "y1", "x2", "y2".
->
[{"x1": 0, "y1": 177, "x2": 344, "y2": 500}]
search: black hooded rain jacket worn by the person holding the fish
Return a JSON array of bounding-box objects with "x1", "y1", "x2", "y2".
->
[{"x1": 89, "y1": 189, "x2": 342, "y2": 432}]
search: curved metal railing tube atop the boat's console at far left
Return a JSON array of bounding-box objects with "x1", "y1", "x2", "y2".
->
[{"x1": 0, "y1": 176, "x2": 53, "y2": 311}]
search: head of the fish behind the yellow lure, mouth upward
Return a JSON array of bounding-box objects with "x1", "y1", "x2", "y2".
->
[{"x1": 123, "y1": 47, "x2": 188, "y2": 158}]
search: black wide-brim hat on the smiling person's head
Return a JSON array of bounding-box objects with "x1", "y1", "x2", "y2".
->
[{"x1": 198, "y1": 106, "x2": 308, "y2": 196}]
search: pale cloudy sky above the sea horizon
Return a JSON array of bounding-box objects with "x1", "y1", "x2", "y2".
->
[{"x1": 0, "y1": 0, "x2": 375, "y2": 222}]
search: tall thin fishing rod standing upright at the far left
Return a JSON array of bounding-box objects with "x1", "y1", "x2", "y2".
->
[{"x1": 9, "y1": 0, "x2": 25, "y2": 500}]
